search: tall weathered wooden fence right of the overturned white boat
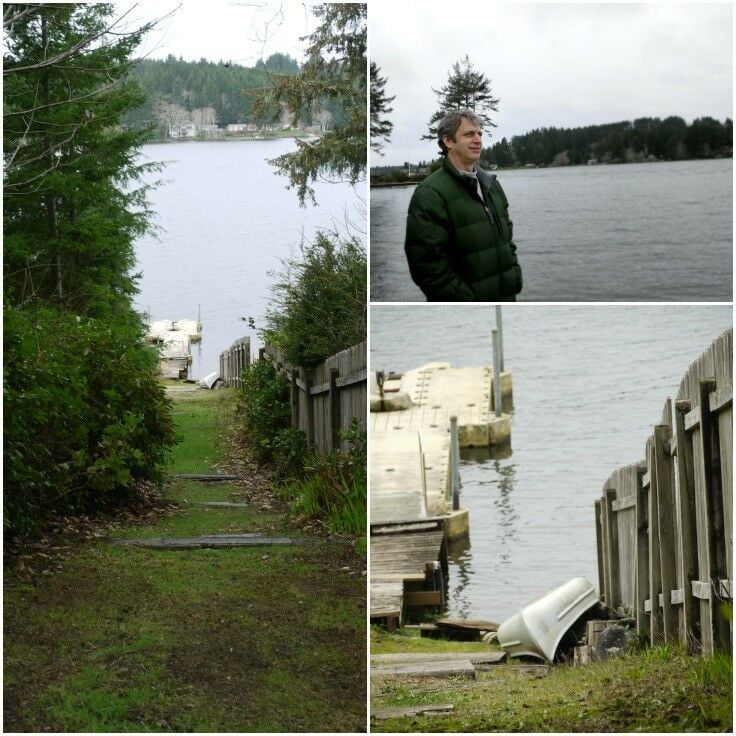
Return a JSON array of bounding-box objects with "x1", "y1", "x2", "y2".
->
[{"x1": 595, "y1": 330, "x2": 733, "y2": 654}]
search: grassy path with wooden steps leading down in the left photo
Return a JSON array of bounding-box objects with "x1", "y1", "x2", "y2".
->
[{"x1": 4, "y1": 392, "x2": 366, "y2": 732}]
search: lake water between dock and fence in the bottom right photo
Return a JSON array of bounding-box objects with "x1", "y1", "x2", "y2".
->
[{"x1": 370, "y1": 304, "x2": 732, "y2": 622}]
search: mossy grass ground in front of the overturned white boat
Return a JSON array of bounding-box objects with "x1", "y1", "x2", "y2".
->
[{"x1": 371, "y1": 630, "x2": 733, "y2": 733}]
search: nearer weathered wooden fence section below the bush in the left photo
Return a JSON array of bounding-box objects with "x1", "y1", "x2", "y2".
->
[{"x1": 261, "y1": 342, "x2": 368, "y2": 455}]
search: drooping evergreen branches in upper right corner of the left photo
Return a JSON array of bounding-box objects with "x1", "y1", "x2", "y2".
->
[{"x1": 254, "y1": 3, "x2": 368, "y2": 205}]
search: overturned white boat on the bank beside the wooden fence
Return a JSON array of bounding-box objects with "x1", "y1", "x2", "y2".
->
[{"x1": 498, "y1": 578, "x2": 599, "y2": 662}]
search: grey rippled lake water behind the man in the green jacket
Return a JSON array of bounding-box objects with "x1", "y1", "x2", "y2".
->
[{"x1": 371, "y1": 159, "x2": 733, "y2": 301}]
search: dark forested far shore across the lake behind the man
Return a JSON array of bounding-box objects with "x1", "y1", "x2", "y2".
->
[{"x1": 371, "y1": 116, "x2": 733, "y2": 184}]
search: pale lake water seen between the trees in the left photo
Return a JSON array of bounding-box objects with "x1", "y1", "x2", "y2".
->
[{"x1": 136, "y1": 138, "x2": 365, "y2": 378}]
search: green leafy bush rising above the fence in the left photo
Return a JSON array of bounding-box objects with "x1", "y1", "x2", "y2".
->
[{"x1": 261, "y1": 232, "x2": 367, "y2": 369}]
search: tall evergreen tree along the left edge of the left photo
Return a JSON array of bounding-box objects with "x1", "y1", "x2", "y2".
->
[{"x1": 3, "y1": 3, "x2": 157, "y2": 313}]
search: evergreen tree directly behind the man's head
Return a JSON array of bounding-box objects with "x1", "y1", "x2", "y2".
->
[{"x1": 422, "y1": 55, "x2": 500, "y2": 140}]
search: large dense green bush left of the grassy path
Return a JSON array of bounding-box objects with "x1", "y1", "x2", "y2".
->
[{"x1": 3, "y1": 307, "x2": 175, "y2": 534}]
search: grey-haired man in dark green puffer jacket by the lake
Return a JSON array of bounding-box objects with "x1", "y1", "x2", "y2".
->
[{"x1": 405, "y1": 110, "x2": 521, "y2": 302}]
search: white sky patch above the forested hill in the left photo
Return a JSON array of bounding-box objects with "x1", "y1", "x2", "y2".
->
[{"x1": 116, "y1": 0, "x2": 316, "y2": 66}]
